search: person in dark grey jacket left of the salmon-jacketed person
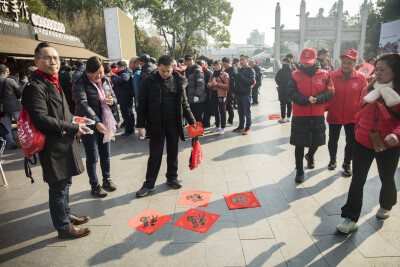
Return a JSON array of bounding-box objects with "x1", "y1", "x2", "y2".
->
[{"x1": 185, "y1": 55, "x2": 206, "y2": 121}]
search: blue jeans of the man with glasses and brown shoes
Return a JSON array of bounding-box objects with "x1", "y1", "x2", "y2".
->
[{"x1": 49, "y1": 177, "x2": 72, "y2": 232}]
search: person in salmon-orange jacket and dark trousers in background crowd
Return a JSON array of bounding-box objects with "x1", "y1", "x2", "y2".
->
[{"x1": 207, "y1": 60, "x2": 229, "y2": 134}]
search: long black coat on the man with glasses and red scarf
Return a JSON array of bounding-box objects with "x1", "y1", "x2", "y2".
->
[{"x1": 22, "y1": 73, "x2": 85, "y2": 183}]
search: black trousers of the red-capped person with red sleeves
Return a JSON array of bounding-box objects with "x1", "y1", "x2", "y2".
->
[{"x1": 328, "y1": 123, "x2": 355, "y2": 164}]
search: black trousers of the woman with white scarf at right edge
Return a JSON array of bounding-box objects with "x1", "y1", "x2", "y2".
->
[{"x1": 342, "y1": 141, "x2": 400, "y2": 222}]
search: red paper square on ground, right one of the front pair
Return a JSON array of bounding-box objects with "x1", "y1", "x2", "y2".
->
[{"x1": 174, "y1": 209, "x2": 219, "y2": 234}]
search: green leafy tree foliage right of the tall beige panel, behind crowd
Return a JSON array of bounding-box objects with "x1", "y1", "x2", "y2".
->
[{"x1": 135, "y1": 0, "x2": 233, "y2": 56}]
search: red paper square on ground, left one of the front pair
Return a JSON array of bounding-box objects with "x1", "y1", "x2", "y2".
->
[{"x1": 125, "y1": 209, "x2": 172, "y2": 235}]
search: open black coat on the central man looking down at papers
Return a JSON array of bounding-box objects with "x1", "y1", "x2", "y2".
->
[{"x1": 137, "y1": 71, "x2": 196, "y2": 141}]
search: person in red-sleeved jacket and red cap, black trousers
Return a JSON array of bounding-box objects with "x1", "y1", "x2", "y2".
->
[{"x1": 326, "y1": 48, "x2": 367, "y2": 176}]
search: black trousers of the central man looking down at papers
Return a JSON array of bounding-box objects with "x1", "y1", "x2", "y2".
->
[{"x1": 143, "y1": 126, "x2": 179, "y2": 188}]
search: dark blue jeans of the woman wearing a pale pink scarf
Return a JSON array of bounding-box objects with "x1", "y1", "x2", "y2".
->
[{"x1": 82, "y1": 129, "x2": 111, "y2": 189}]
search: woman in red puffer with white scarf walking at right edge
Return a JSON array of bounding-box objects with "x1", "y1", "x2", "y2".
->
[{"x1": 336, "y1": 54, "x2": 400, "y2": 234}]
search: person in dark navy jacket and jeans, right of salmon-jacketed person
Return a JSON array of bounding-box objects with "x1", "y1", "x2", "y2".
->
[{"x1": 233, "y1": 55, "x2": 256, "y2": 135}]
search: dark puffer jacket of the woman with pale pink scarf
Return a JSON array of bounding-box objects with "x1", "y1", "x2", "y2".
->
[{"x1": 72, "y1": 73, "x2": 117, "y2": 122}]
